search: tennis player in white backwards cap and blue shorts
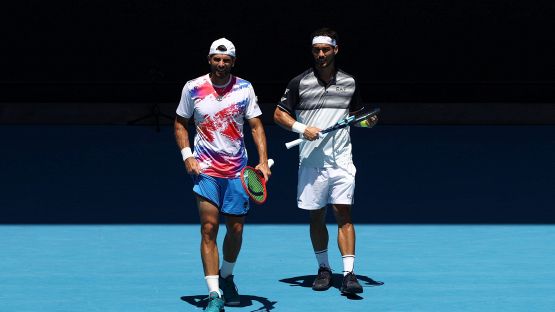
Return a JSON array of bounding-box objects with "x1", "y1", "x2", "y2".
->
[{"x1": 174, "y1": 38, "x2": 271, "y2": 311}]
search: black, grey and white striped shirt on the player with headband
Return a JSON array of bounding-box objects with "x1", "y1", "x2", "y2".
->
[{"x1": 278, "y1": 68, "x2": 364, "y2": 168}]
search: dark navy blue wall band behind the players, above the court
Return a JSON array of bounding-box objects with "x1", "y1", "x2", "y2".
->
[{"x1": 0, "y1": 125, "x2": 555, "y2": 223}]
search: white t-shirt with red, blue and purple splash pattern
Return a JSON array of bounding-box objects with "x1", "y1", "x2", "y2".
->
[{"x1": 176, "y1": 74, "x2": 262, "y2": 178}]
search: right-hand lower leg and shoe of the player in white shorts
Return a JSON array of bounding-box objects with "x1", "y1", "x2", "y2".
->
[{"x1": 333, "y1": 204, "x2": 362, "y2": 293}]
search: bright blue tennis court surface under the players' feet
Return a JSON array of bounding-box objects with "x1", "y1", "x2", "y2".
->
[{"x1": 0, "y1": 224, "x2": 555, "y2": 312}]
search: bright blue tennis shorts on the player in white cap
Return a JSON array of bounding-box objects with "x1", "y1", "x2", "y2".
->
[{"x1": 193, "y1": 174, "x2": 249, "y2": 216}]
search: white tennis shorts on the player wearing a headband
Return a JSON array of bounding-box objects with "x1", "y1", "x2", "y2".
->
[{"x1": 297, "y1": 163, "x2": 356, "y2": 210}]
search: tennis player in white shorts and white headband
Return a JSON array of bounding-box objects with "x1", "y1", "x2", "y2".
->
[{"x1": 274, "y1": 28, "x2": 377, "y2": 293}]
